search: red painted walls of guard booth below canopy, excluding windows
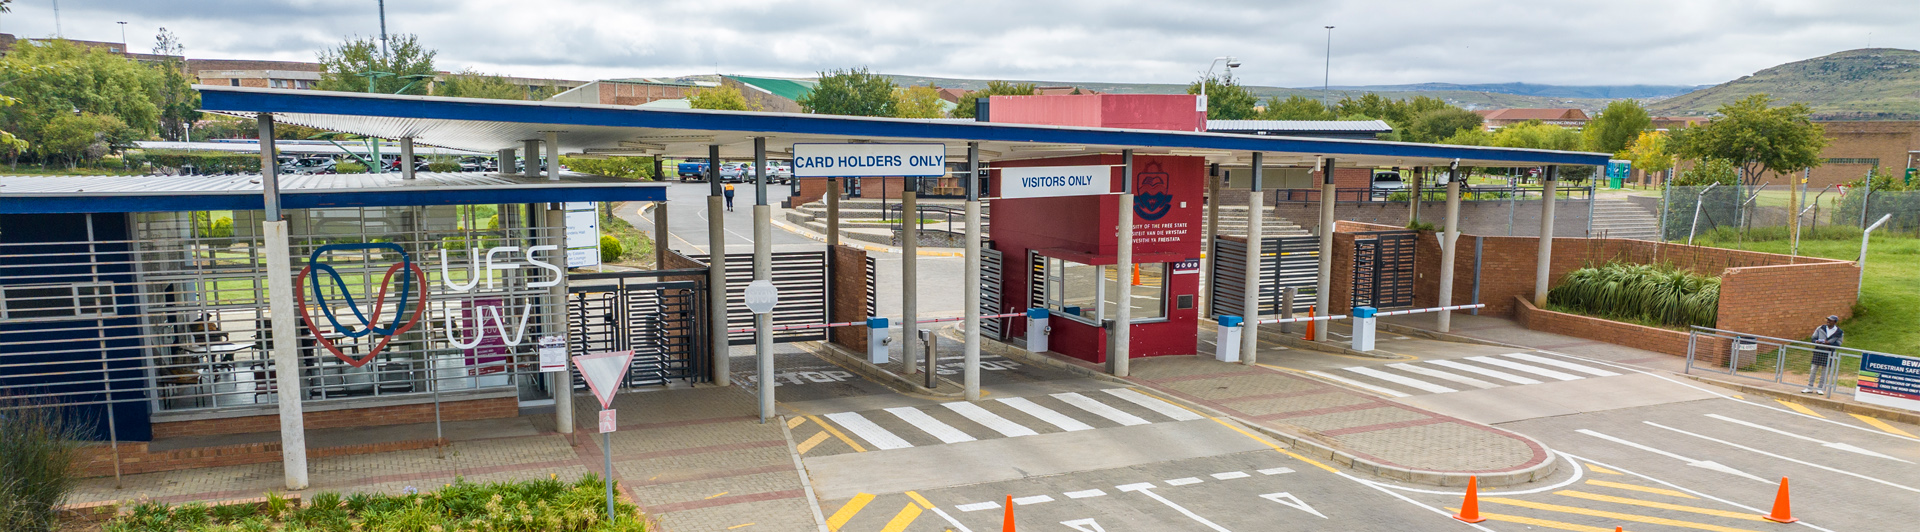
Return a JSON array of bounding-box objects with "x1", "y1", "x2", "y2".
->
[{"x1": 991, "y1": 153, "x2": 1206, "y2": 363}]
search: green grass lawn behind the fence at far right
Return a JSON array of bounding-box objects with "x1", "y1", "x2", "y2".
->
[{"x1": 1697, "y1": 234, "x2": 1920, "y2": 355}]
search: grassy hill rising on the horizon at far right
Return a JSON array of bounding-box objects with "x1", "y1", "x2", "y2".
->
[{"x1": 1649, "y1": 48, "x2": 1920, "y2": 119}]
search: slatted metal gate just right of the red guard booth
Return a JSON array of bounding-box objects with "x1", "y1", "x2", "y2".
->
[{"x1": 1208, "y1": 236, "x2": 1319, "y2": 317}]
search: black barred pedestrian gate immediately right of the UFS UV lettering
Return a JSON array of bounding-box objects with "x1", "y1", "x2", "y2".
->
[{"x1": 566, "y1": 269, "x2": 712, "y2": 382}]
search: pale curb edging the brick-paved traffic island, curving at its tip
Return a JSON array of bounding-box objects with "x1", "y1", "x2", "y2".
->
[{"x1": 941, "y1": 326, "x2": 1559, "y2": 488}]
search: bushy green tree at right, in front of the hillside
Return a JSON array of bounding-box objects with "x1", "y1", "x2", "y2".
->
[{"x1": 1674, "y1": 94, "x2": 1828, "y2": 186}]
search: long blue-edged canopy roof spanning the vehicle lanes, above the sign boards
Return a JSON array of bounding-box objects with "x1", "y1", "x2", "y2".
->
[{"x1": 196, "y1": 85, "x2": 1607, "y2": 167}]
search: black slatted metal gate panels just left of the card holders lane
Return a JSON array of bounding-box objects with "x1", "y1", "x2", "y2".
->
[{"x1": 693, "y1": 252, "x2": 828, "y2": 346}]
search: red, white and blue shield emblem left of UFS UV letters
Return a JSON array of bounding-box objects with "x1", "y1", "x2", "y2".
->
[{"x1": 294, "y1": 242, "x2": 426, "y2": 367}]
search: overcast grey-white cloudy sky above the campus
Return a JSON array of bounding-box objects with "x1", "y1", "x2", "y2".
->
[{"x1": 0, "y1": 0, "x2": 1920, "y2": 86}]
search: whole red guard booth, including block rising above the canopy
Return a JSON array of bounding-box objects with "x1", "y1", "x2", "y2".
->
[{"x1": 989, "y1": 94, "x2": 1206, "y2": 363}]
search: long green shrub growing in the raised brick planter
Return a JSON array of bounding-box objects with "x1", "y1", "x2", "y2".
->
[{"x1": 1548, "y1": 263, "x2": 1720, "y2": 326}]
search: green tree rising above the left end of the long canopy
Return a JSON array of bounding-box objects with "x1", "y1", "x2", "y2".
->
[{"x1": 317, "y1": 35, "x2": 438, "y2": 94}]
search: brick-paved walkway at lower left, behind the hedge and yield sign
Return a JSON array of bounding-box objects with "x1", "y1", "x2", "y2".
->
[{"x1": 69, "y1": 386, "x2": 820, "y2": 530}]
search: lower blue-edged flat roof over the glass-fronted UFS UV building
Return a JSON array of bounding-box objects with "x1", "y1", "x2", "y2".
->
[{"x1": 0, "y1": 173, "x2": 666, "y2": 213}]
